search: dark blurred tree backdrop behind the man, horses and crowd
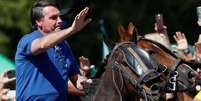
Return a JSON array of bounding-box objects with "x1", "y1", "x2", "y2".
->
[{"x1": 0, "y1": 0, "x2": 201, "y2": 68}]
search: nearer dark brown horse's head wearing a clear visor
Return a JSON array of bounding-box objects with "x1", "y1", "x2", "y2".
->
[{"x1": 108, "y1": 42, "x2": 162, "y2": 100}]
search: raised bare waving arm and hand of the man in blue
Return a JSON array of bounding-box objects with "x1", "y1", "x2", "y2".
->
[{"x1": 31, "y1": 7, "x2": 91, "y2": 55}]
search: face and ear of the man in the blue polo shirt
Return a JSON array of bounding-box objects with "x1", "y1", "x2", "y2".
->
[{"x1": 37, "y1": 6, "x2": 62, "y2": 34}]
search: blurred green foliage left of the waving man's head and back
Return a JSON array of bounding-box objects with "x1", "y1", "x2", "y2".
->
[{"x1": 0, "y1": 0, "x2": 34, "y2": 59}]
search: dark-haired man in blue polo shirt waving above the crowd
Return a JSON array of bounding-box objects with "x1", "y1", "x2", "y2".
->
[{"x1": 15, "y1": 0, "x2": 91, "y2": 101}]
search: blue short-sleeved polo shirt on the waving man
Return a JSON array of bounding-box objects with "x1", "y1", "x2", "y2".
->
[{"x1": 15, "y1": 31, "x2": 79, "y2": 101}]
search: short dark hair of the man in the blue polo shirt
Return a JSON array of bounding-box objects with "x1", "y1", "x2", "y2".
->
[{"x1": 30, "y1": 0, "x2": 60, "y2": 30}]
